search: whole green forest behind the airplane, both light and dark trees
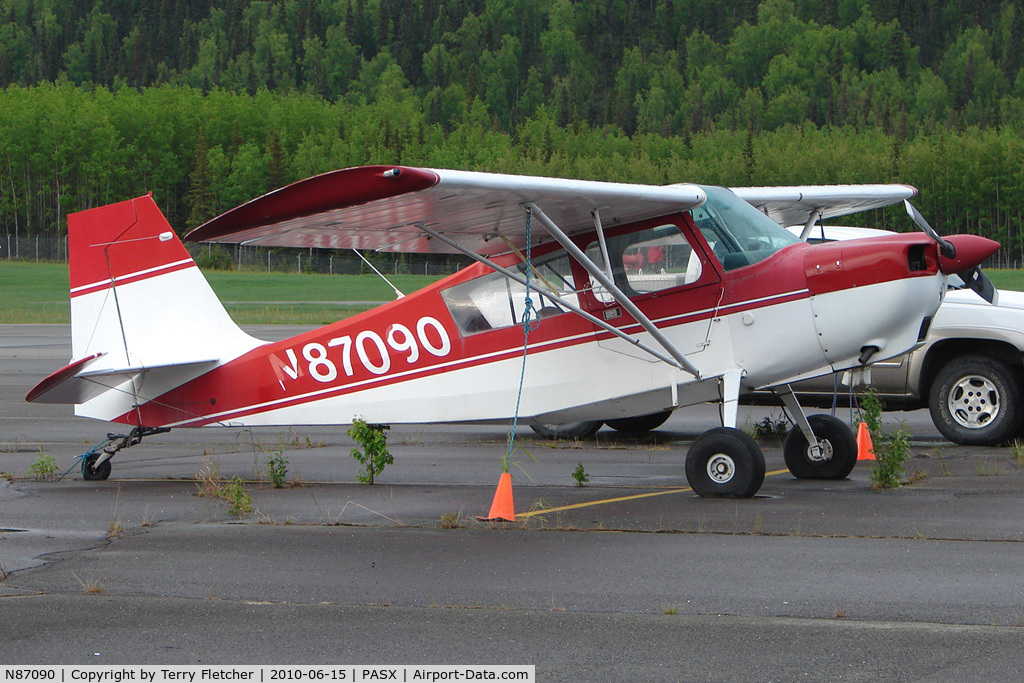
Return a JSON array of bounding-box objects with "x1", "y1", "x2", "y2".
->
[{"x1": 0, "y1": 0, "x2": 1024, "y2": 259}]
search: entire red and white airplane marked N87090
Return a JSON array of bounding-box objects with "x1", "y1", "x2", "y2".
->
[{"x1": 27, "y1": 167, "x2": 998, "y2": 497}]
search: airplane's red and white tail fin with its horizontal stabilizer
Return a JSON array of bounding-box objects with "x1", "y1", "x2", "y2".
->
[{"x1": 26, "y1": 195, "x2": 263, "y2": 426}]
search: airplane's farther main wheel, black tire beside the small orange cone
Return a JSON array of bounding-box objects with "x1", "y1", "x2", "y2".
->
[{"x1": 782, "y1": 415, "x2": 857, "y2": 479}]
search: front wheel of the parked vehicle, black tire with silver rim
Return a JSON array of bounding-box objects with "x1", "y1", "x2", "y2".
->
[{"x1": 928, "y1": 355, "x2": 1022, "y2": 445}]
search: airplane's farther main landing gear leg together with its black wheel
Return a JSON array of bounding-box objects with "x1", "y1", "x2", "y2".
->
[{"x1": 776, "y1": 385, "x2": 857, "y2": 479}]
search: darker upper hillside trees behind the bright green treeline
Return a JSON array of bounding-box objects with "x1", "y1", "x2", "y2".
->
[{"x1": 0, "y1": 0, "x2": 1024, "y2": 134}]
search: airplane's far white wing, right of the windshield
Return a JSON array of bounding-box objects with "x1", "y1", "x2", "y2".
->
[{"x1": 731, "y1": 184, "x2": 918, "y2": 226}]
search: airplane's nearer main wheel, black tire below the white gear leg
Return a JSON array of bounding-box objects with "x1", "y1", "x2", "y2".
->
[{"x1": 686, "y1": 427, "x2": 765, "y2": 498}]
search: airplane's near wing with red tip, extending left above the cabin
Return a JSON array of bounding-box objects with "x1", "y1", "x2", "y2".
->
[{"x1": 185, "y1": 166, "x2": 706, "y2": 255}]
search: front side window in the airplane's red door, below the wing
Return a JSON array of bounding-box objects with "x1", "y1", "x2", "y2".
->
[{"x1": 587, "y1": 223, "x2": 703, "y2": 303}]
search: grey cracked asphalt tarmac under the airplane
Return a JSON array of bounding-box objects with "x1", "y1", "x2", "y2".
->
[{"x1": 0, "y1": 326, "x2": 1024, "y2": 681}]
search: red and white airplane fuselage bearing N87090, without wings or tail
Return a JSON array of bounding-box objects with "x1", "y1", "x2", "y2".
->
[{"x1": 94, "y1": 213, "x2": 944, "y2": 427}]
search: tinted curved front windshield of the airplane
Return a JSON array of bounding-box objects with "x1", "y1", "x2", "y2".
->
[{"x1": 691, "y1": 186, "x2": 800, "y2": 270}]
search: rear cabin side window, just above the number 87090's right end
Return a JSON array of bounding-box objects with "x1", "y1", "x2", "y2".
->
[{"x1": 441, "y1": 251, "x2": 580, "y2": 336}]
